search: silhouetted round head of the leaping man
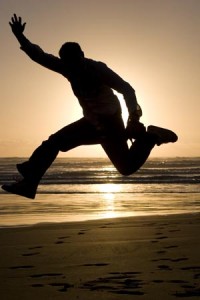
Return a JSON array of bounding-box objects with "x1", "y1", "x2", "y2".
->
[{"x1": 59, "y1": 42, "x2": 84, "y2": 64}]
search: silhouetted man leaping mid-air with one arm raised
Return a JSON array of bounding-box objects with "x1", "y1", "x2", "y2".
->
[{"x1": 2, "y1": 14, "x2": 177, "y2": 199}]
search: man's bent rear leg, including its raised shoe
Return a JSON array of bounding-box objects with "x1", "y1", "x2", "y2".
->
[{"x1": 101, "y1": 117, "x2": 178, "y2": 175}]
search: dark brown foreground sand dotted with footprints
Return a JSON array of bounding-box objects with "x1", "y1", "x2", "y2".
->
[{"x1": 0, "y1": 214, "x2": 200, "y2": 300}]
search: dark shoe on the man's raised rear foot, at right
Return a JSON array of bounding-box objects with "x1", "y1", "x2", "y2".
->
[{"x1": 147, "y1": 125, "x2": 178, "y2": 146}]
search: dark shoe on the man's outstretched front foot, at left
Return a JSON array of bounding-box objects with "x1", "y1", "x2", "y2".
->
[{"x1": 2, "y1": 180, "x2": 37, "y2": 199}]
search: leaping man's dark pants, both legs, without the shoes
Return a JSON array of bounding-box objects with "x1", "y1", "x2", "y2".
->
[{"x1": 18, "y1": 114, "x2": 155, "y2": 184}]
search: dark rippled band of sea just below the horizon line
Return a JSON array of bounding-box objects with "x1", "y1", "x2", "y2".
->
[{"x1": 0, "y1": 158, "x2": 200, "y2": 185}]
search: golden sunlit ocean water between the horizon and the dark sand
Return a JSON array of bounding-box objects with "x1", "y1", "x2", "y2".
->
[{"x1": 0, "y1": 157, "x2": 200, "y2": 227}]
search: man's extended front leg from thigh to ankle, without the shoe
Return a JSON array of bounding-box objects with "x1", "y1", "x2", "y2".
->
[{"x1": 17, "y1": 118, "x2": 100, "y2": 181}]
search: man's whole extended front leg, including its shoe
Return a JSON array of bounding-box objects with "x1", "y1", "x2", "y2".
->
[{"x1": 2, "y1": 118, "x2": 99, "y2": 199}]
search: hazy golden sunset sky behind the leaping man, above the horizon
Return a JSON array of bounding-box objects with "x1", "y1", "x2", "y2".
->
[{"x1": 0, "y1": 0, "x2": 200, "y2": 157}]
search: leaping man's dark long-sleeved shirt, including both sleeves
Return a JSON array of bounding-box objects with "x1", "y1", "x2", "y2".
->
[{"x1": 21, "y1": 38, "x2": 138, "y2": 123}]
